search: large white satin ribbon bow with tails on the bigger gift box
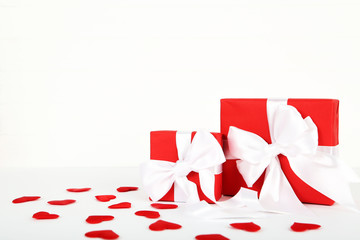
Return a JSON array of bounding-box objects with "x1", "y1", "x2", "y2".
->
[{"x1": 228, "y1": 100, "x2": 355, "y2": 213}]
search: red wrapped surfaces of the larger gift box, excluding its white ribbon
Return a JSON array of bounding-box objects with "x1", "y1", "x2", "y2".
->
[{"x1": 221, "y1": 99, "x2": 339, "y2": 205}]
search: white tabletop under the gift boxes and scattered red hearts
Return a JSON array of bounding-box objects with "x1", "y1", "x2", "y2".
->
[{"x1": 0, "y1": 168, "x2": 360, "y2": 240}]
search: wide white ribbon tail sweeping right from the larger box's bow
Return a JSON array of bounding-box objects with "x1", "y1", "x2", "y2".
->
[{"x1": 289, "y1": 156, "x2": 358, "y2": 211}]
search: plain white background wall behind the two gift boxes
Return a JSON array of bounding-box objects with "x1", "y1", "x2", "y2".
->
[{"x1": 0, "y1": 0, "x2": 360, "y2": 167}]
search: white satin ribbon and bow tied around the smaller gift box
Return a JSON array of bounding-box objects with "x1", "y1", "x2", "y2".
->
[{"x1": 141, "y1": 131, "x2": 225, "y2": 202}]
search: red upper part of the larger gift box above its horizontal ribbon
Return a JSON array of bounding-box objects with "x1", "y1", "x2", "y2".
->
[{"x1": 220, "y1": 98, "x2": 339, "y2": 146}]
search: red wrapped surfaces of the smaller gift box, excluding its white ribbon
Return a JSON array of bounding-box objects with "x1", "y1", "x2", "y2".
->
[{"x1": 150, "y1": 131, "x2": 223, "y2": 203}]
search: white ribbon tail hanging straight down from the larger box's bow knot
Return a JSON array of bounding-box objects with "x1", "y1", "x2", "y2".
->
[{"x1": 259, "y1": 158, "x2": 313, "y2": 216}]
